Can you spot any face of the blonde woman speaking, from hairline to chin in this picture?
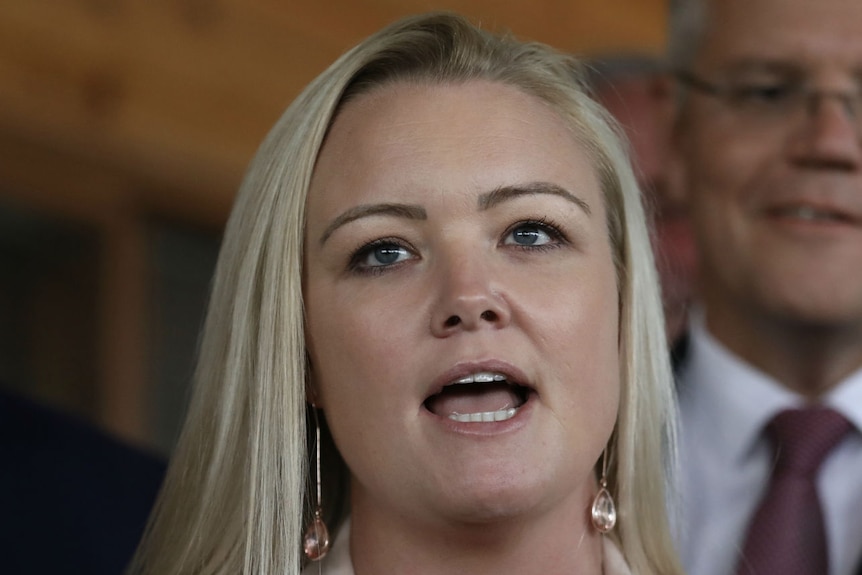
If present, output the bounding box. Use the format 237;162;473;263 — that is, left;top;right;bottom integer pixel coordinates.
304;81;620;521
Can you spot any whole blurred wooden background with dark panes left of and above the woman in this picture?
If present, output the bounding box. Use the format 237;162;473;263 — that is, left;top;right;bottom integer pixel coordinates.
0;0;665;454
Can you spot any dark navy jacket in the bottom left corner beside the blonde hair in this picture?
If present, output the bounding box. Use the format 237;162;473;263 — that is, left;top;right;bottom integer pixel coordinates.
0;392;164;575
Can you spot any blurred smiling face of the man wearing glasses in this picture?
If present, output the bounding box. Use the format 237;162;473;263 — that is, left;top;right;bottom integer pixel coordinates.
674;0;862;348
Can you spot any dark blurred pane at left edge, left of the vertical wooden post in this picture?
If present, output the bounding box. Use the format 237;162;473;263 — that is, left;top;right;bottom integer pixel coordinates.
0;199;102;420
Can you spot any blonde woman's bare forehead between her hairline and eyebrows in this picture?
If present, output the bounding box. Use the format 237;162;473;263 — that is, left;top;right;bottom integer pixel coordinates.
313;80;592;197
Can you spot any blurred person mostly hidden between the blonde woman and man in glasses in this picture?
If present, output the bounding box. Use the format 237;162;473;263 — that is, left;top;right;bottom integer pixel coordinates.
591;56;696;343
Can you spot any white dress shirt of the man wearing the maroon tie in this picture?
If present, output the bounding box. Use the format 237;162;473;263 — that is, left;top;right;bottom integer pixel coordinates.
676;313;862;575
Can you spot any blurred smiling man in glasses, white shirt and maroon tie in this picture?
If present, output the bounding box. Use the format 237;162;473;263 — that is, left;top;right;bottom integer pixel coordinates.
670;0;862;575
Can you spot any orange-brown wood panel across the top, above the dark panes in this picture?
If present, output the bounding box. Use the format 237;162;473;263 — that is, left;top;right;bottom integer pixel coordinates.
0;0;664;225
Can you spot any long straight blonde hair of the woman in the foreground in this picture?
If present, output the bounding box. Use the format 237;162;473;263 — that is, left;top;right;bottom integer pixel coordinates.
132;14;681;575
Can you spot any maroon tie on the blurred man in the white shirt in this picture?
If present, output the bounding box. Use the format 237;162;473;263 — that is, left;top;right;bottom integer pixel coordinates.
737;407;851;575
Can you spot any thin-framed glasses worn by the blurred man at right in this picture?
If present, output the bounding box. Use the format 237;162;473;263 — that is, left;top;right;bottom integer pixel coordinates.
676;71;862;133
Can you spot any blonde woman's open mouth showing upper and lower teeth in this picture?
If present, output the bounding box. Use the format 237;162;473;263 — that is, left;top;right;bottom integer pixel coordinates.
425;372;531;423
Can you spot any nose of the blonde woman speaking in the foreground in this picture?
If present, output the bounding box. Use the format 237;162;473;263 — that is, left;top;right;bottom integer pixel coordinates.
431;259;511;337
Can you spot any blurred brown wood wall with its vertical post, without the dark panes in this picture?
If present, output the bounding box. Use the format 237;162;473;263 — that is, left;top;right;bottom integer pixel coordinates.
0;0;665;450
